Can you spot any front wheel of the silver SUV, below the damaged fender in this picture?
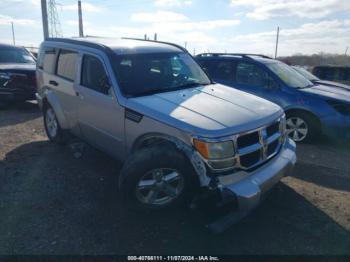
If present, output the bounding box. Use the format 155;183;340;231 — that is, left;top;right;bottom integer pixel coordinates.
119;143;198;210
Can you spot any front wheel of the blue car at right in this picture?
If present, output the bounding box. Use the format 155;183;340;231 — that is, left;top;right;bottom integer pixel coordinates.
286;112;320;143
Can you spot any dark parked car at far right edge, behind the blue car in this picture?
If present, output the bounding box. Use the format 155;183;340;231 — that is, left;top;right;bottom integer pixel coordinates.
312;66;350;85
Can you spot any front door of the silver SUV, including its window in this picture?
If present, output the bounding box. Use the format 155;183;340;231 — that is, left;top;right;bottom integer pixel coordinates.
76;53;125;158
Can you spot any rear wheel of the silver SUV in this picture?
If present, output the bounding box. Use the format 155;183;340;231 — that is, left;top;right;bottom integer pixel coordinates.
44;105;68;145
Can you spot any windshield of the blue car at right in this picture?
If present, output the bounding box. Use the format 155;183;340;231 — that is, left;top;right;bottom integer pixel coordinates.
266;61;313;88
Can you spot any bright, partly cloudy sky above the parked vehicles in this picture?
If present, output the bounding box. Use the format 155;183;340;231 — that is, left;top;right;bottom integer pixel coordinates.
0;0;350;55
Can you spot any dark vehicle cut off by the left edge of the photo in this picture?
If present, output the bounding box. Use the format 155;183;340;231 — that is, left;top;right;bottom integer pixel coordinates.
0;44;36;105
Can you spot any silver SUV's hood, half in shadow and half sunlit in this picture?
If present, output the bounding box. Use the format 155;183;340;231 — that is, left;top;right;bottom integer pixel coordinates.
128;84;283;137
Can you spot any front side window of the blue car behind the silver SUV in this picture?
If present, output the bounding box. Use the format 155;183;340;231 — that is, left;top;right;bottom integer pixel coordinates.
236;63;277;88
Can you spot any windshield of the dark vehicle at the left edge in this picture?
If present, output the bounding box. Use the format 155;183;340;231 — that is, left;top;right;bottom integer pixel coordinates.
0;48;35;64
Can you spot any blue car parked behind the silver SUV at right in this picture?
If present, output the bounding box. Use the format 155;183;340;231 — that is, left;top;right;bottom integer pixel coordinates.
196;53;350;142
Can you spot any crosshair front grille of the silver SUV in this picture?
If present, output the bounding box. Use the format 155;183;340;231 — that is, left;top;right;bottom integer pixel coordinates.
236;118;283;169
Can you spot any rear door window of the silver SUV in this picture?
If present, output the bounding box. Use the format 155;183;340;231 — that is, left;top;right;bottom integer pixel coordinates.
56;50;78;81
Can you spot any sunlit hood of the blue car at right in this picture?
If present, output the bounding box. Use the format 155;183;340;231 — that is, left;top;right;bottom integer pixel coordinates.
299;84;350;102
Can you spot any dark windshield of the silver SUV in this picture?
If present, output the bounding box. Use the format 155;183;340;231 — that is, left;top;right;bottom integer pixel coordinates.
116;53;211;97
